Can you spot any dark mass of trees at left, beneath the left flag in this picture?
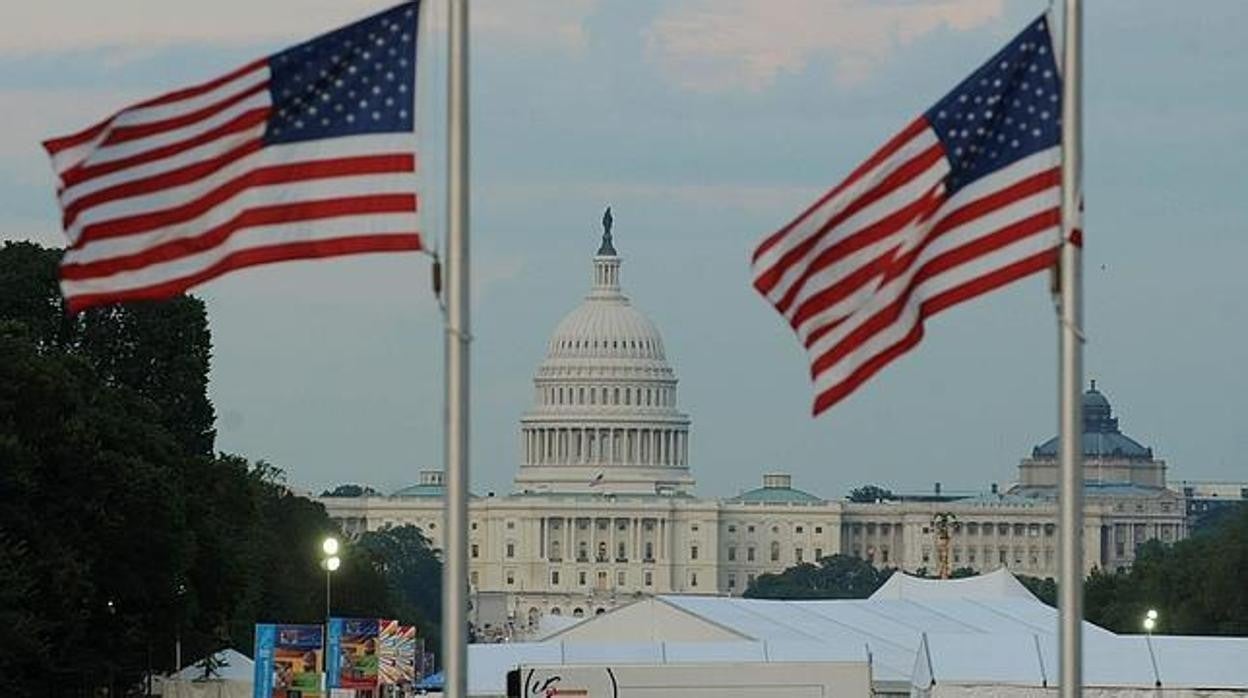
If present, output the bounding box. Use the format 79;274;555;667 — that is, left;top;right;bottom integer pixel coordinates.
0;242;441;696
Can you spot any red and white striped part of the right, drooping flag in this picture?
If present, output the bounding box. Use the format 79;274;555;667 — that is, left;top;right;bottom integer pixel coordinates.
754;117;1061;415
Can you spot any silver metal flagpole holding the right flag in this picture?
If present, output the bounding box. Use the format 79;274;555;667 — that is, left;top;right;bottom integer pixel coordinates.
1057;0;1083;698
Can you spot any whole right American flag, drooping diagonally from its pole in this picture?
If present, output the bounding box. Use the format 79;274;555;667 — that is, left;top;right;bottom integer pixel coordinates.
753;16;1062;415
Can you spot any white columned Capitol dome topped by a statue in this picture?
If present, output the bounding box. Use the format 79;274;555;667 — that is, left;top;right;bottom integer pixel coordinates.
515;219;693;494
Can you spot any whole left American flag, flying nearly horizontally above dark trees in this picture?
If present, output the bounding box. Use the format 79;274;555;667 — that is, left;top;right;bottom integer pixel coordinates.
44;1;422;311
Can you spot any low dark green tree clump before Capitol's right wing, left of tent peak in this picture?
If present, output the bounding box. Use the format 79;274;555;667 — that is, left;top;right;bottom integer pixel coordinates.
745;554;895;599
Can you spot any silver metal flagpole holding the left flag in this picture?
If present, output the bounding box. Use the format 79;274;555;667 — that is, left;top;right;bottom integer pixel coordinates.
442;0;470;698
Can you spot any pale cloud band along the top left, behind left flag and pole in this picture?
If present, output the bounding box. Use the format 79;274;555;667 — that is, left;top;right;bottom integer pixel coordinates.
0;0;597;57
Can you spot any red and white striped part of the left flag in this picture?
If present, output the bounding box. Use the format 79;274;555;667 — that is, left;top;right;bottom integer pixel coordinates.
44;60;422;311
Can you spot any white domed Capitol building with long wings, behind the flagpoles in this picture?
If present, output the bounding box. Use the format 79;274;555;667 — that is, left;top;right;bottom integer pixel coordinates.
319;224;1187;626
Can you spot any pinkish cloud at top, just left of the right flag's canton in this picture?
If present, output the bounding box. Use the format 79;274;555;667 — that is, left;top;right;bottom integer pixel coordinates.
644;0;1002;92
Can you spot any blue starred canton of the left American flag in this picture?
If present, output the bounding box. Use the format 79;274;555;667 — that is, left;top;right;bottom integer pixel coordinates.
265;1;419;144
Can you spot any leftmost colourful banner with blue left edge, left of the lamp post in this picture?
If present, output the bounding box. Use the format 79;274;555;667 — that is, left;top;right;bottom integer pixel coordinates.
252;623;324;698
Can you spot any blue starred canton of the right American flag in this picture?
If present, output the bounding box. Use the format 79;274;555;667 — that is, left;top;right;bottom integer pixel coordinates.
926;17;1062;195
